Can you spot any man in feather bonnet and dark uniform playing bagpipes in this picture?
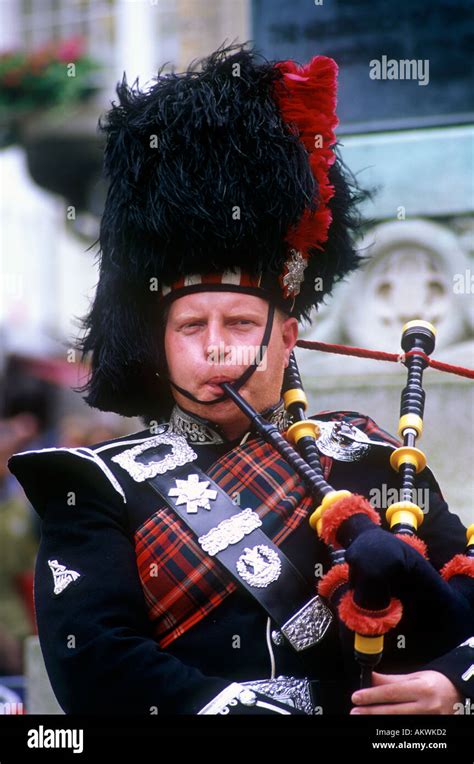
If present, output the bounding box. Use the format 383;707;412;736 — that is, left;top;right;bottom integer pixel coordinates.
9;46;473;715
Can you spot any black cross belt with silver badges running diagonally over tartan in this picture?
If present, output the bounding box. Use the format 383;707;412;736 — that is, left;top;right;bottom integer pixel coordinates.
147;464;332;652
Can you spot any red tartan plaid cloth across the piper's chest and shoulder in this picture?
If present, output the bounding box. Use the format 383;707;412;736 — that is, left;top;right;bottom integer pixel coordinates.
135;412;398;648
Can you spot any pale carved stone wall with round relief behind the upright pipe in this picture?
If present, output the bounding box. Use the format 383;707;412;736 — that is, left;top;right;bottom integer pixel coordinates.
298;215;474;524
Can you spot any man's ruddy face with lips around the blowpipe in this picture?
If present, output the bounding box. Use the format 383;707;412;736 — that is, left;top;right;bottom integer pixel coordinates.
165;292;298;438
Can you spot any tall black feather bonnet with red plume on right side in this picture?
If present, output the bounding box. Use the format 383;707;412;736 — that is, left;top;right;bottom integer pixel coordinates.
77;45;366;421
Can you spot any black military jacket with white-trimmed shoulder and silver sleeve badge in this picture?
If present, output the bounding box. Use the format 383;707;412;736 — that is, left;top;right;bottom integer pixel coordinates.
9;407;474;715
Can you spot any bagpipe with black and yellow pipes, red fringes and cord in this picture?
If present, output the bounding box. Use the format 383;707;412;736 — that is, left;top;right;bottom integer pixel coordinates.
221;320;474;687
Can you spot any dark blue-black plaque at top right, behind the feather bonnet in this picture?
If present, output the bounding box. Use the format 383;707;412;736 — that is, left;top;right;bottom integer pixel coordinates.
252;0;474;132
